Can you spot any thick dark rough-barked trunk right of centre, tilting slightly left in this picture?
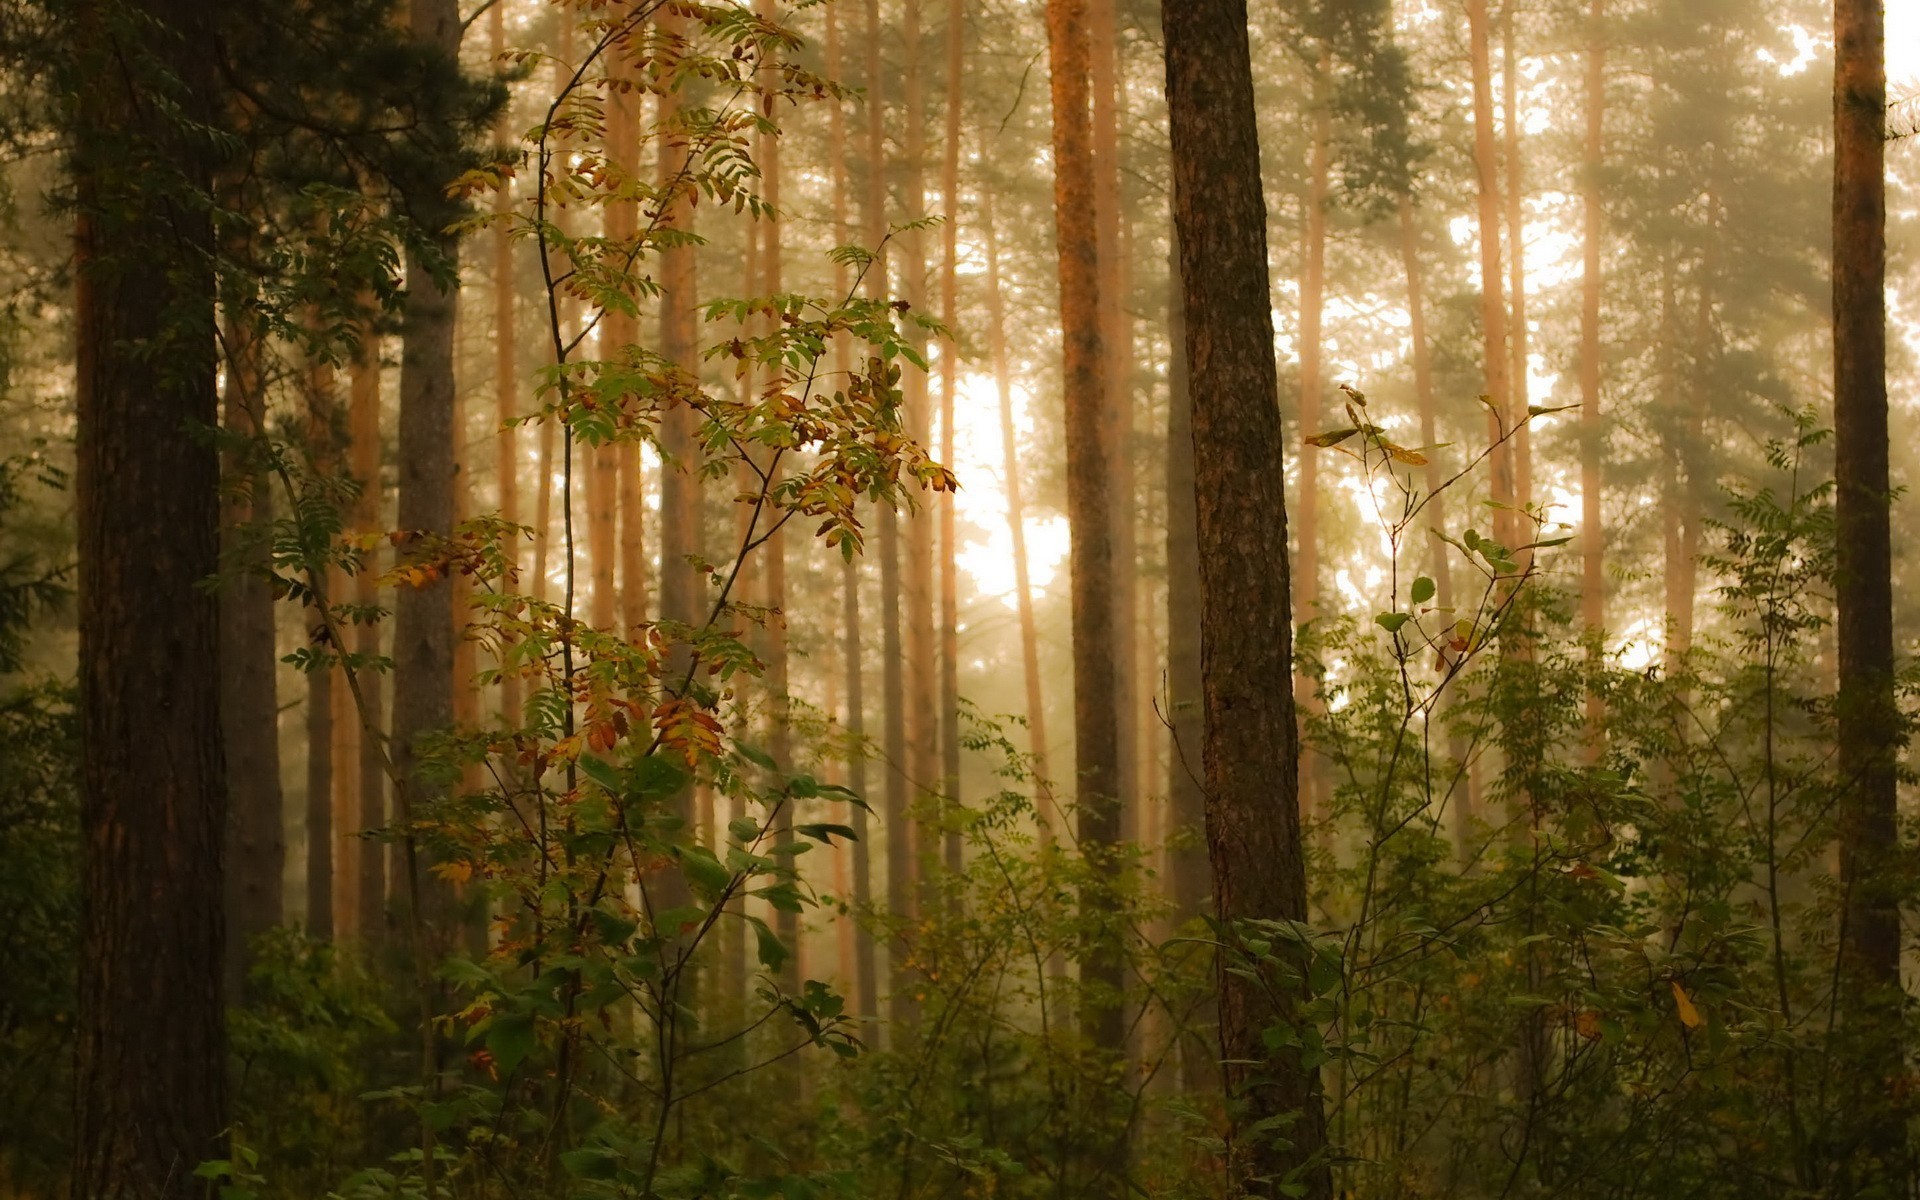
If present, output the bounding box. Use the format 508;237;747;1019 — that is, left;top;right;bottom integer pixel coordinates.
1160;0;1332;1200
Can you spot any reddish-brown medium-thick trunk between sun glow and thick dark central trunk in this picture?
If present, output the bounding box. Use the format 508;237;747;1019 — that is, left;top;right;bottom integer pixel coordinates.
1046;0;1125;1050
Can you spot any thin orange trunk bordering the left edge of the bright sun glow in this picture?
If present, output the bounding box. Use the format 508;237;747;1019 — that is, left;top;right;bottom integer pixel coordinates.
935;0;966;874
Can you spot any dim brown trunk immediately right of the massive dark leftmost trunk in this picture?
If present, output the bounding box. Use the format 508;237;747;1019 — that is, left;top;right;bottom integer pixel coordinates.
219;315;286;1000
